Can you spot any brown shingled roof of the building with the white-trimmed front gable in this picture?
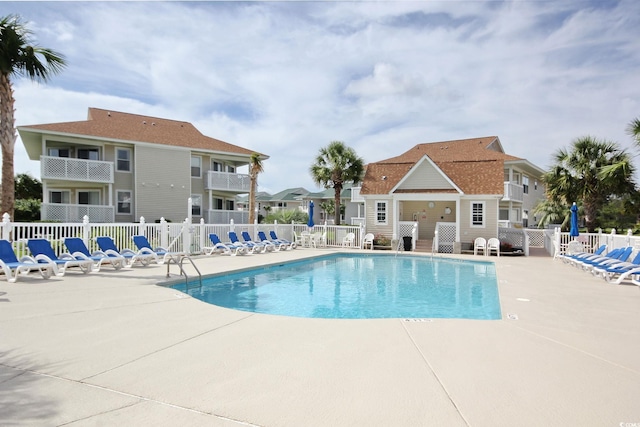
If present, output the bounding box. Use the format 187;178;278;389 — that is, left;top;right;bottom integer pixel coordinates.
360;136;522;194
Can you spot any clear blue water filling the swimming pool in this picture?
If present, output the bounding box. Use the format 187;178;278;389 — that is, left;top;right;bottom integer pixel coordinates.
173;254;501;319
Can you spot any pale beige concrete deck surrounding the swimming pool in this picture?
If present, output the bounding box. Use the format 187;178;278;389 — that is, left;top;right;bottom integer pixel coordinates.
0;249;640;427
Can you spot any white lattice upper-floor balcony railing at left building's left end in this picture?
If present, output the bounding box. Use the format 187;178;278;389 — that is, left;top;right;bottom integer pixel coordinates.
40;156;113;183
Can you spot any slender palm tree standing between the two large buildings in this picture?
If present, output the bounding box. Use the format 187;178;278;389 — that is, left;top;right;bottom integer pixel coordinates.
310;141;364;225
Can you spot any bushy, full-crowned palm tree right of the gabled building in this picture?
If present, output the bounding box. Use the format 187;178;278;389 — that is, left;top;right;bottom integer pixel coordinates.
544;136;635;232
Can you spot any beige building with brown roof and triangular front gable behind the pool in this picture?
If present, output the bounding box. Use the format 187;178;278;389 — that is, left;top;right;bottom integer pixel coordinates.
353;136;544;249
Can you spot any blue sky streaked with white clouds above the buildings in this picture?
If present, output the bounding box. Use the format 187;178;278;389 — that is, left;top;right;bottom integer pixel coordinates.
5;0;640;193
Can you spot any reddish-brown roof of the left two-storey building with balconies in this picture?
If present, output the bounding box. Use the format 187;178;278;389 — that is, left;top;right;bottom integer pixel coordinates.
18;108;268;158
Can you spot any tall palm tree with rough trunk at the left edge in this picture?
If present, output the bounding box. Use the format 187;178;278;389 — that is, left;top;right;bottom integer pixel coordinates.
0;15;65;216
